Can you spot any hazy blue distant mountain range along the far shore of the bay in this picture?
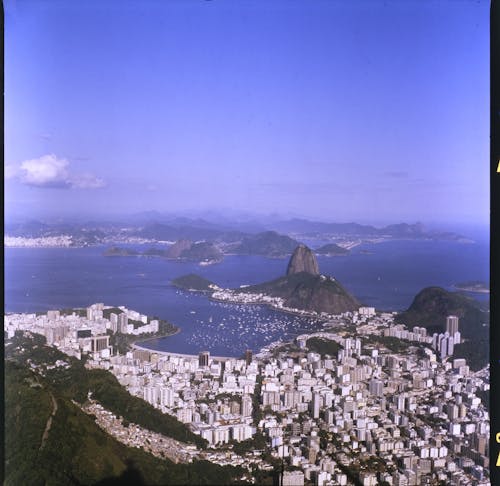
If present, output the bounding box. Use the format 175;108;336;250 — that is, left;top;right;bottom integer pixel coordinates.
5;218;465;249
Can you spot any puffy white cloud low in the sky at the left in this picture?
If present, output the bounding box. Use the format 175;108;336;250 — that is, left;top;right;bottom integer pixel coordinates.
9;154;106;189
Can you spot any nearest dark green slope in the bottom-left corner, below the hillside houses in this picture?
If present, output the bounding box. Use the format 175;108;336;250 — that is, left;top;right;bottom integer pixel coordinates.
4;361;247;486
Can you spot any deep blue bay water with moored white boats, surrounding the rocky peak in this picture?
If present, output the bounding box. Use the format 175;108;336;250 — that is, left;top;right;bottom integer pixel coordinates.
5;240;489;356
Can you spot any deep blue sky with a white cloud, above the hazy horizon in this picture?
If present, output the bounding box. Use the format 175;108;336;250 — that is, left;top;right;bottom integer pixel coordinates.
5;0;489;224
